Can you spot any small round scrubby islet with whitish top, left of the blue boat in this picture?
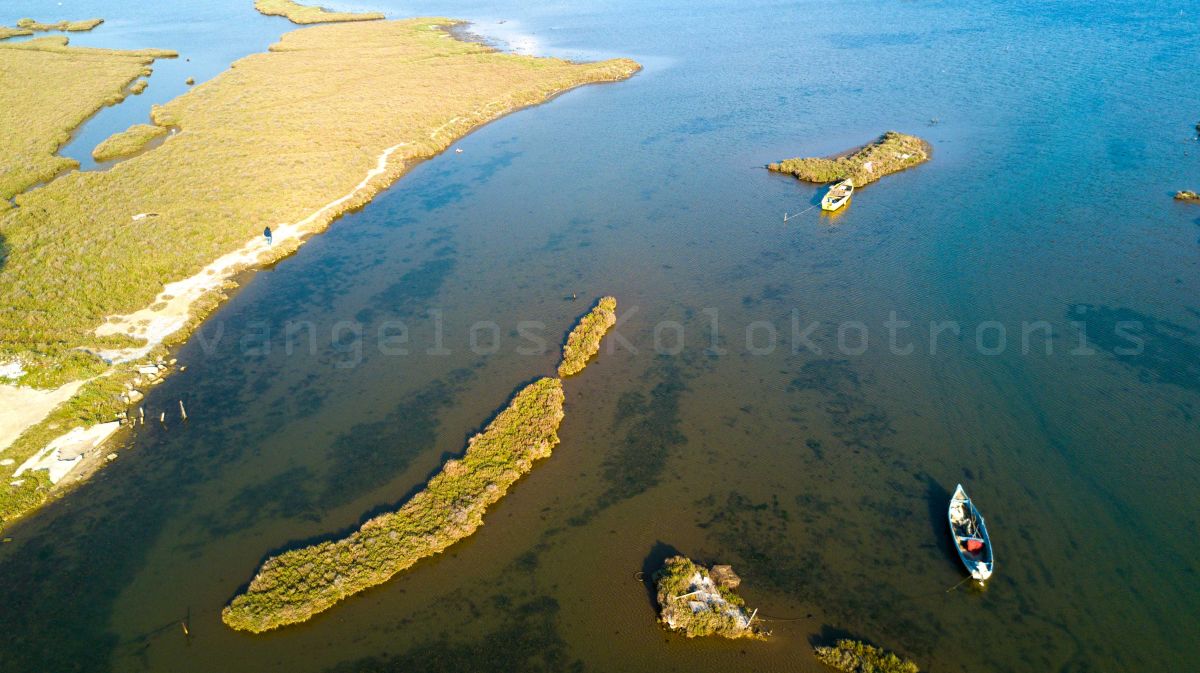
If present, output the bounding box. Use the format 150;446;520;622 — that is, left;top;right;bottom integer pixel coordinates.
654;557;768;638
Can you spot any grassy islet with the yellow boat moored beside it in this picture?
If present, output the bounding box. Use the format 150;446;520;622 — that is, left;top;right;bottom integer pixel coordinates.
767;131;930;187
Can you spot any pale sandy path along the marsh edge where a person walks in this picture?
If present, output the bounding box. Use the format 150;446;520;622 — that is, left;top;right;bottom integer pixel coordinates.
96;143;408;362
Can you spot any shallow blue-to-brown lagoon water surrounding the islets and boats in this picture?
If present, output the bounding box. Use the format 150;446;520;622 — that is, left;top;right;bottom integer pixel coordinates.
0;1;1200;672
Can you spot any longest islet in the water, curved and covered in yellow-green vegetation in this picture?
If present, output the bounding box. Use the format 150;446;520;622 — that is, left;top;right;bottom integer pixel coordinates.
221;378;563;633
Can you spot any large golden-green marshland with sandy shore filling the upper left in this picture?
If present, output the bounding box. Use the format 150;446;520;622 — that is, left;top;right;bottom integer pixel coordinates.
0;18;640;525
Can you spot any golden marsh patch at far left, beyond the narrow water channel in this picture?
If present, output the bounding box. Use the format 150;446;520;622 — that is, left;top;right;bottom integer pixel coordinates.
0;36;176;197
